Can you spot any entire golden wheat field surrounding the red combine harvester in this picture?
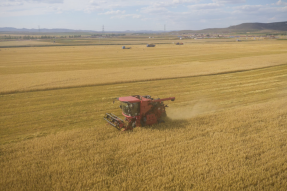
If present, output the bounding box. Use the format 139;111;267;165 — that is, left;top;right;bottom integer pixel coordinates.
0;38;287;190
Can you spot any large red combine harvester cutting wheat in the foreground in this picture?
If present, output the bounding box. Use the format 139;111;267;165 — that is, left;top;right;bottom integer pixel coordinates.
104;95;175;131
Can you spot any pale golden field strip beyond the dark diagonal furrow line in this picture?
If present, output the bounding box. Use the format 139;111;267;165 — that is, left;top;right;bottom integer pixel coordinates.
0;41;287;92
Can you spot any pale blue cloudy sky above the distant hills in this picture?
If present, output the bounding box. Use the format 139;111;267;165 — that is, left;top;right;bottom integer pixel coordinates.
0;0;287;31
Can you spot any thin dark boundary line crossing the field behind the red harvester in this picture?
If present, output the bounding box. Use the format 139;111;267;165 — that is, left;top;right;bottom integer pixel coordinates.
0;63;287;95
